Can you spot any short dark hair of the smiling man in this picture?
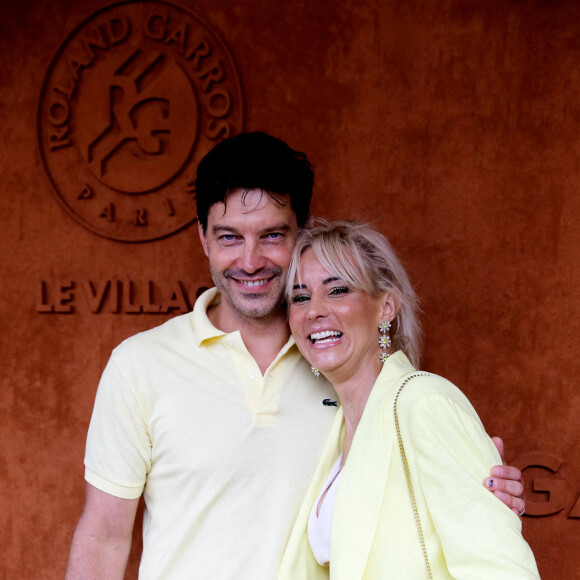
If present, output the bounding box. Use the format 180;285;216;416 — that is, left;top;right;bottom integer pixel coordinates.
195;132;314;232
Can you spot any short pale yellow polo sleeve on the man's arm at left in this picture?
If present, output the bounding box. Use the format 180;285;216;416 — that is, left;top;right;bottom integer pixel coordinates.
85;354;151;499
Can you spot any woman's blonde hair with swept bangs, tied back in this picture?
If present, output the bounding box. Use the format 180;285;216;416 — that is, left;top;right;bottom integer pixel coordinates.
286;219;421;367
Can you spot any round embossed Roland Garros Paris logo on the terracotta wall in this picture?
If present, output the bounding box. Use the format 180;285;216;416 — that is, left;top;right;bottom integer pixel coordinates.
38;0;243;242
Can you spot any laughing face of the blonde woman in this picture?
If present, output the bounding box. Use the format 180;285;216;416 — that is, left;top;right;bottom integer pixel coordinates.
289;249;394;383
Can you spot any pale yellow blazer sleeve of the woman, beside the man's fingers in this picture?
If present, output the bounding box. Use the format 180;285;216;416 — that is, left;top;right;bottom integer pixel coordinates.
401;376;539;580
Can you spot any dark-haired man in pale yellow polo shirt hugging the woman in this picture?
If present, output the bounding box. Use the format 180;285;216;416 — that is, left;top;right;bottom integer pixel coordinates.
67;133;523;580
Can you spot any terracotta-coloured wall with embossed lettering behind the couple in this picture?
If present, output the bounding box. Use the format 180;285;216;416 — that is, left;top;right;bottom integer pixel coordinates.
0;0;580;580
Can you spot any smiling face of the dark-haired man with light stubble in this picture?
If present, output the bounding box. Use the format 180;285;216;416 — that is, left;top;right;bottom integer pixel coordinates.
199;188;298;319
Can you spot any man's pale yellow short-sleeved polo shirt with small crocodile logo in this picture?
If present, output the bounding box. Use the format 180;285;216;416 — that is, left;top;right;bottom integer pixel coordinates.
85;289;336;580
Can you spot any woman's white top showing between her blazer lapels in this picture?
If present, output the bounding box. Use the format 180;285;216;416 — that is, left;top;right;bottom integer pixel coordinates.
308;453;342;566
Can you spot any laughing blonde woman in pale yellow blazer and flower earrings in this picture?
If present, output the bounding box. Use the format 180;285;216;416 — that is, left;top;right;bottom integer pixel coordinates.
278;222;539;580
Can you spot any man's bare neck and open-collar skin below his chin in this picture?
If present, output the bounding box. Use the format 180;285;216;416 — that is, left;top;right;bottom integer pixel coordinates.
207;301;290;374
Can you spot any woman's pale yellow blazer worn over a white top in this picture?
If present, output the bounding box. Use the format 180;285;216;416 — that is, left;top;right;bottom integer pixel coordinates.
278;351;539;580
